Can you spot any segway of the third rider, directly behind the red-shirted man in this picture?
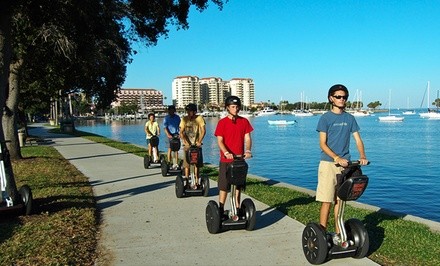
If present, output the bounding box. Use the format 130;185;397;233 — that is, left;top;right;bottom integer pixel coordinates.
176;145;209;198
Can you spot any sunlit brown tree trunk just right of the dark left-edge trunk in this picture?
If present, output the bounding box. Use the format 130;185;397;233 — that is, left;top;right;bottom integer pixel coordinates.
2;59;23;160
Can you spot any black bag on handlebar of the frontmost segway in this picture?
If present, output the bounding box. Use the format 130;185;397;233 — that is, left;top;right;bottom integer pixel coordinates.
336;166;368;201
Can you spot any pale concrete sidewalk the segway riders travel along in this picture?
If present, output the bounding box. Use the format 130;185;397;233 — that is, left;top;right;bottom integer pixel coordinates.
29;124;377;265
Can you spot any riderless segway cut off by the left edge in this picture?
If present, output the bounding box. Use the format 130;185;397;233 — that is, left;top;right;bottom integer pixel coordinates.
0;142;33;215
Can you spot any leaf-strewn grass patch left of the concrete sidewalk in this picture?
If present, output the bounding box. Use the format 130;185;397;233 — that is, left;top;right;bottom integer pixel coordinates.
0;146;99;265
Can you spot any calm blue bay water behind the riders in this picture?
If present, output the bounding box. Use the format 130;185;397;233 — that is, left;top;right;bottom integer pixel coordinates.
77;114;440;222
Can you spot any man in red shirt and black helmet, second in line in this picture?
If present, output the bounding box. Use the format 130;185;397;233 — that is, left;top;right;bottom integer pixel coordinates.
214;96;254;215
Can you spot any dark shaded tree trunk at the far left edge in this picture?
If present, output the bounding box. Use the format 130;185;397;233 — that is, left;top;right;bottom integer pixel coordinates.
0;1;19;201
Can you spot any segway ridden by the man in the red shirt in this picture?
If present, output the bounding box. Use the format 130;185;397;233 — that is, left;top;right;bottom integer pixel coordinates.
206;157;256;234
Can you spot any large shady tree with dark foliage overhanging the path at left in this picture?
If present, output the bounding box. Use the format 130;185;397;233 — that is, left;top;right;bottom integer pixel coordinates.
0;0;227;203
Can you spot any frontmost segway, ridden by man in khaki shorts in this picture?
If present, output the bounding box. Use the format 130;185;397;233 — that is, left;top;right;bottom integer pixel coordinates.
302;161;370;264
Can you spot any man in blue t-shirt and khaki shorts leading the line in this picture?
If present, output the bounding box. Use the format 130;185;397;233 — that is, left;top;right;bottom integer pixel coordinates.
316;84;368;242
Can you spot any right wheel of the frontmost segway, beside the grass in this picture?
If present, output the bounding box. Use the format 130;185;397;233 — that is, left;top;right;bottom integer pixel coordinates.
345;219;370;259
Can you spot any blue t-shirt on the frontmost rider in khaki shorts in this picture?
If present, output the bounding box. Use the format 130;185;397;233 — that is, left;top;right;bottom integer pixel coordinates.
316;111;359;162
